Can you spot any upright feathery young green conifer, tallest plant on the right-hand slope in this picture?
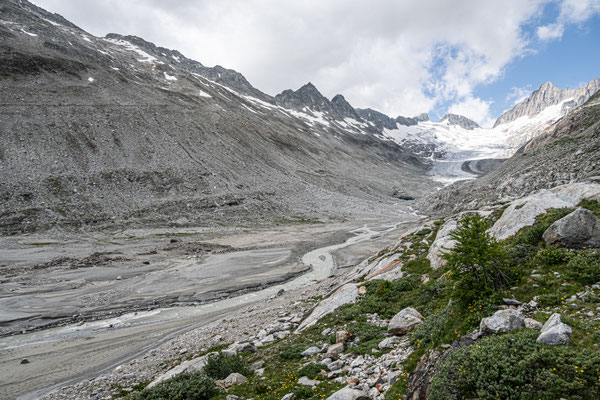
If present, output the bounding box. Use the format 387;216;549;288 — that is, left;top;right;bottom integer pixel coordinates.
444;214;516;306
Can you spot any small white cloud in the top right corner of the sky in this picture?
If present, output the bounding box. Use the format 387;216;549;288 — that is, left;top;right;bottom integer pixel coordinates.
537;0;600;41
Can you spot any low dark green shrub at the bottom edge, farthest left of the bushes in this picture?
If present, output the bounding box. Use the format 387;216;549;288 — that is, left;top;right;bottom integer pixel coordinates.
132;372;218;400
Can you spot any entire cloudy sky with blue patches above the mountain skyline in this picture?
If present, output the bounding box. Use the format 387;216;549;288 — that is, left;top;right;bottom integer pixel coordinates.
33;0;600;126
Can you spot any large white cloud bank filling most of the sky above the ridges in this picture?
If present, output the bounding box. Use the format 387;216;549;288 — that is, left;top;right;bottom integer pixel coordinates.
33;0;548;118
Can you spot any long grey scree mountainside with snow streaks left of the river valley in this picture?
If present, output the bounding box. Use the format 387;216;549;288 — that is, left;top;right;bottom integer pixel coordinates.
0;0;434;233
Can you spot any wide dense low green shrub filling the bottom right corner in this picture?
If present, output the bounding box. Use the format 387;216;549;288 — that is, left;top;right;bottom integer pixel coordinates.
429;331;600;400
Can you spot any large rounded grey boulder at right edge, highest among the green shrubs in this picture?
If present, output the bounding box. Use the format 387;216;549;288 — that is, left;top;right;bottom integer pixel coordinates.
543;207;600;249
